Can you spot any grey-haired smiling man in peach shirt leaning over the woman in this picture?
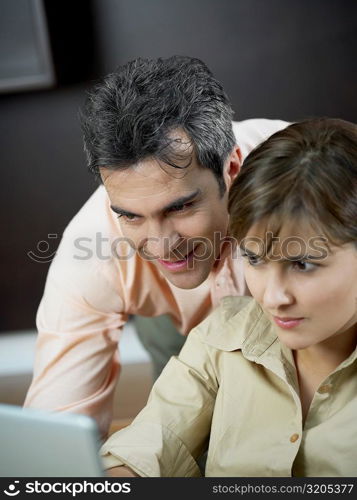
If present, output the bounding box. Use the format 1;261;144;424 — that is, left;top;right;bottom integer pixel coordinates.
25;56;287;435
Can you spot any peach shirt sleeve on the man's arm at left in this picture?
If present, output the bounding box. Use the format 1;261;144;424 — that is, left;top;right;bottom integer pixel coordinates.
24;188;126;437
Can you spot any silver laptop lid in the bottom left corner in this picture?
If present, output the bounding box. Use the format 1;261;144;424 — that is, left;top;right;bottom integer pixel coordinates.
0;404;105;477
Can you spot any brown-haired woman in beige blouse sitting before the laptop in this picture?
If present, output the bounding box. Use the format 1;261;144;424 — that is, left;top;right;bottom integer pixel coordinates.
98;119;357;477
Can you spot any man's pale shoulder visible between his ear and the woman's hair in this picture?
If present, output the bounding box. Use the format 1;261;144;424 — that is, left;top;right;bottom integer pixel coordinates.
233;118;290;159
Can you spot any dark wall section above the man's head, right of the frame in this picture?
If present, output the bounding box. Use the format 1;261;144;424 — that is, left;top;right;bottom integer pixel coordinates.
93;0;357;120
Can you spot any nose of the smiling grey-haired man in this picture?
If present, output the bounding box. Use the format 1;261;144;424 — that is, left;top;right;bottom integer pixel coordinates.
143;224;183;260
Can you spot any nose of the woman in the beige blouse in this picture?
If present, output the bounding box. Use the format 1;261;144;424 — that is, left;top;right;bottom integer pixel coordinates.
263;272;294;311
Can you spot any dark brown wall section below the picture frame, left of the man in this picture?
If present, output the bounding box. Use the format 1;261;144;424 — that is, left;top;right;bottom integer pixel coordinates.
0;86;96;331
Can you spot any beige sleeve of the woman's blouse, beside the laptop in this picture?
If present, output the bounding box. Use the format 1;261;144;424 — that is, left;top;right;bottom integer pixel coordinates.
101;328;218;477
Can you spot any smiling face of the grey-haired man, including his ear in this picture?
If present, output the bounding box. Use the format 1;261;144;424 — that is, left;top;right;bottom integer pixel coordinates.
101;135;240;289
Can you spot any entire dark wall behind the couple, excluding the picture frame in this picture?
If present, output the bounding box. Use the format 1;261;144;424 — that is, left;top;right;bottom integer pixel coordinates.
0;0;357;331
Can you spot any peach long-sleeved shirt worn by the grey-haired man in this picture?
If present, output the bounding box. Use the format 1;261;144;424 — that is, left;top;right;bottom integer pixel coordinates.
25;119;288;435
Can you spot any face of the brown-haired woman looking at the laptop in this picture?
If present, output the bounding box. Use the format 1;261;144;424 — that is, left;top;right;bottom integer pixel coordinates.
241;223;357;349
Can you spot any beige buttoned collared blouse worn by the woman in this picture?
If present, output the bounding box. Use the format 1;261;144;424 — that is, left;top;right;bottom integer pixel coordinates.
101;297;357;477
